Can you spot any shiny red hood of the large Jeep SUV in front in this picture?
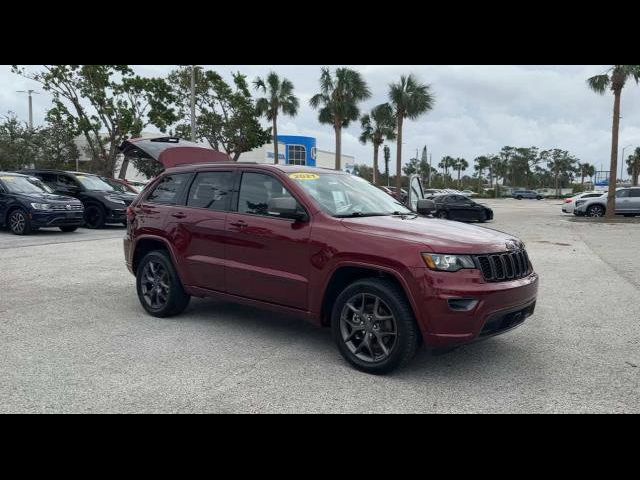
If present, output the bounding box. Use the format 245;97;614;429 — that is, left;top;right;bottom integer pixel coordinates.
342;216;519;254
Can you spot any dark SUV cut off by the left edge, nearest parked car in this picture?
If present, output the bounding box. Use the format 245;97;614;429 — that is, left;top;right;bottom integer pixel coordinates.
0;172;84;235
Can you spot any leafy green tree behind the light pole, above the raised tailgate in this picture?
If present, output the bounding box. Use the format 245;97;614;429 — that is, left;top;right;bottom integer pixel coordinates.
169;68;271;161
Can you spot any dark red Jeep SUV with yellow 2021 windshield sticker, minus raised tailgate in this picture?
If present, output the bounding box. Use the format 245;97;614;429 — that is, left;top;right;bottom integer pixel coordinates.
124;138;538;373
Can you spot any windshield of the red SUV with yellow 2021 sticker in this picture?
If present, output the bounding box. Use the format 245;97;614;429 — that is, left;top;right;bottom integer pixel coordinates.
289;173;412;217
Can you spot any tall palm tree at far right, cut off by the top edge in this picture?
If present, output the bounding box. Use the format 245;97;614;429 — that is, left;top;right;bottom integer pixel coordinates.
587;65;640;218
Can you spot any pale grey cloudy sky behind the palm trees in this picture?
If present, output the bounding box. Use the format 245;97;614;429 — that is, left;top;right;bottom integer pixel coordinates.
0;65;640;174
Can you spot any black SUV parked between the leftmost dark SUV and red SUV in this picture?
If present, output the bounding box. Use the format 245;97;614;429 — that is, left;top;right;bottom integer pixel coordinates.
20;170;136;228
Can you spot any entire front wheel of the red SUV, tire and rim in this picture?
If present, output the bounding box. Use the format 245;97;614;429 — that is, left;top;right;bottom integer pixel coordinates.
331;278;420;374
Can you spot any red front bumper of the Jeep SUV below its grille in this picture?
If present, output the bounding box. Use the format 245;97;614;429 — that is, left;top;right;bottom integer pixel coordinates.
413;268;538;347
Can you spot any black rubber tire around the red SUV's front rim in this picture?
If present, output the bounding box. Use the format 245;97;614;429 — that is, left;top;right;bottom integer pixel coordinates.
331;278;421;374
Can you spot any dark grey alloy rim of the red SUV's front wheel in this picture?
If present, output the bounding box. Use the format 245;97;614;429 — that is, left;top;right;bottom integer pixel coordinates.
340;293;398;363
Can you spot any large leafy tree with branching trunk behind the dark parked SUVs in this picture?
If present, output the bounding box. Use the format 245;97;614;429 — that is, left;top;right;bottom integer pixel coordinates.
12;65;176;176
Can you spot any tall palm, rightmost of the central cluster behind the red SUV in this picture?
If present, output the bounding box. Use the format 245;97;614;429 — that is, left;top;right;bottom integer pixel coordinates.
389;74;434;199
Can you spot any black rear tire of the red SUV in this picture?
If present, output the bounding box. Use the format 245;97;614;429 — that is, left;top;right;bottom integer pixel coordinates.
136;250;191;318
